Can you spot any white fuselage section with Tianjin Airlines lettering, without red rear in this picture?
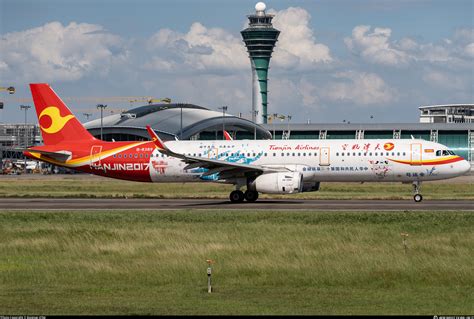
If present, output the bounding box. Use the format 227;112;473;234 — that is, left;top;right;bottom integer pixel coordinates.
150;139;470;182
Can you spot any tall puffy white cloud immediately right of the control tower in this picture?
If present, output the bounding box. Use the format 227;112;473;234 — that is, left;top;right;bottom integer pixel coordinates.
272;7;333;68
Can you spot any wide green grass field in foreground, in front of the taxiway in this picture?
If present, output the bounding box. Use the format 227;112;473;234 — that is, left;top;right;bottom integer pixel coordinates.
0;211;474;315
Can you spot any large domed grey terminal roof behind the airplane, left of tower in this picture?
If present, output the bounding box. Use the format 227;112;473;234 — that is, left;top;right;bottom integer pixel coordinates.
84;103;271;141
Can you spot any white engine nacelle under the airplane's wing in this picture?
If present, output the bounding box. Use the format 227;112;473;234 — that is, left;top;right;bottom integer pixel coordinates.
247;172;303;194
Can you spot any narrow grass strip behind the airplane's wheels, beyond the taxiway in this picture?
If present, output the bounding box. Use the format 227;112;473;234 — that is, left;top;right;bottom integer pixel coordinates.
0;175;474;200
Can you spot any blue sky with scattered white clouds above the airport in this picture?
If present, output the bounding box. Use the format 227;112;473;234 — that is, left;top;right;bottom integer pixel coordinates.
0;0;474;123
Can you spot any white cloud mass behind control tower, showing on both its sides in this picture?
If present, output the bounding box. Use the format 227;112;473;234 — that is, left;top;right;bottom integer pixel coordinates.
145;8;333;72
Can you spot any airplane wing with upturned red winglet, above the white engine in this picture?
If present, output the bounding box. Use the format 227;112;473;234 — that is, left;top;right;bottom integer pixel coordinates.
146;126;281;179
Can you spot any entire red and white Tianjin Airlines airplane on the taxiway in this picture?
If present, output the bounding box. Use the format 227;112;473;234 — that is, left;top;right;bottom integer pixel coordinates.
24;83;470;203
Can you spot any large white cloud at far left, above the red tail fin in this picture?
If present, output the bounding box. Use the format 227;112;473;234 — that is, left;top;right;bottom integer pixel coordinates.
0;22;127;81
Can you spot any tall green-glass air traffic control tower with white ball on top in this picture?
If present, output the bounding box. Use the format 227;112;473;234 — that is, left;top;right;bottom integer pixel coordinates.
240;2;280;124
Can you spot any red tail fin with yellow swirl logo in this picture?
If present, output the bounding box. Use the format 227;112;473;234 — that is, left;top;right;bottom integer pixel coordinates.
30;83;95;145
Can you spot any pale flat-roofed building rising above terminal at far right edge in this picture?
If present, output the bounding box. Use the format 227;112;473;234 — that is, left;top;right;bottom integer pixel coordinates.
419;104;474;123
